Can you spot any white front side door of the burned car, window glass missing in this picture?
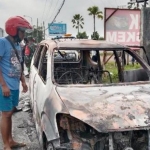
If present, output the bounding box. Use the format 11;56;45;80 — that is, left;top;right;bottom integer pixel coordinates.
34;46;49;127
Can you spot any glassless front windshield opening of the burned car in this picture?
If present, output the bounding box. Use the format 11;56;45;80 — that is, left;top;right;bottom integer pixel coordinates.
53;49;149;84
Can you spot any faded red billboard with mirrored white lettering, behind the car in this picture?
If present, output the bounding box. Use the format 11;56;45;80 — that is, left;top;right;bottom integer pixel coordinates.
105;8;141;45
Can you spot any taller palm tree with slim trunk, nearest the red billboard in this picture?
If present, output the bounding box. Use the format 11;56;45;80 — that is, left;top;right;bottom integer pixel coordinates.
88;6;103;33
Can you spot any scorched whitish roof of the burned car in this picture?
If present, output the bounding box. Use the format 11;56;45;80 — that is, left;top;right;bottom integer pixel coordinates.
41;39;130;50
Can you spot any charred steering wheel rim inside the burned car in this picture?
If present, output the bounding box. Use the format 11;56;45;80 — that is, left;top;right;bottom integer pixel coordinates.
57;71;84;84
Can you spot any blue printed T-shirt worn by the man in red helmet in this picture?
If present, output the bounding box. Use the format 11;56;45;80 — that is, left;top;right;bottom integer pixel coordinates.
0;38;21;90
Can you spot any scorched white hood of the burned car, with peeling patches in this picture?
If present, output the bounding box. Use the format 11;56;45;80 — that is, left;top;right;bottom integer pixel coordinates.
56;84;150;132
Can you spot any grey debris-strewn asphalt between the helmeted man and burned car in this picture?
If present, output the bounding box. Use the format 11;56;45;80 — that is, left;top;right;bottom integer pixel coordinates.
0;78;41;150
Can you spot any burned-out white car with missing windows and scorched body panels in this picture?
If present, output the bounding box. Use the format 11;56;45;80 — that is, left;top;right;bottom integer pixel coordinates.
29;39;150;150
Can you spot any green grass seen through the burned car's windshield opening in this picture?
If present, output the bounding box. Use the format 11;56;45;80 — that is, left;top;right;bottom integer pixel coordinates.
102;62;141;83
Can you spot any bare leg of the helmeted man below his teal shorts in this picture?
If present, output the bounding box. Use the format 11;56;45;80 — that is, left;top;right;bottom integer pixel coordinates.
1;111;12;150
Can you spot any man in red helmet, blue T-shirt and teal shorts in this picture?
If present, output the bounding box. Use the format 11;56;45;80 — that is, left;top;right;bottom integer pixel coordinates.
0;16;32;150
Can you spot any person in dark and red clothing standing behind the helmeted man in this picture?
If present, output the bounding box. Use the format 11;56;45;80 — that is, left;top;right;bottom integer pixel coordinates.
24;36;36;78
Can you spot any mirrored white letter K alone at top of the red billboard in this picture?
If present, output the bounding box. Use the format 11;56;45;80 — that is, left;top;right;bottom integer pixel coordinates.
129;14;139;30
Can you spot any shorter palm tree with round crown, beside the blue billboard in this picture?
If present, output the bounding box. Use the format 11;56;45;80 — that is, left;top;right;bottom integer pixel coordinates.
72;14;84;34
